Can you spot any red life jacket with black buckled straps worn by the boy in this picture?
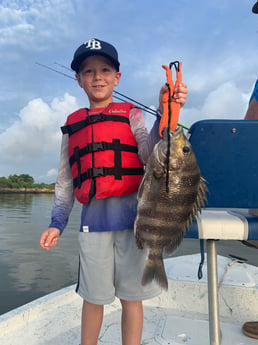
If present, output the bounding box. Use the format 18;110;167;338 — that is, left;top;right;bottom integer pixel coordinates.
61;103;144;204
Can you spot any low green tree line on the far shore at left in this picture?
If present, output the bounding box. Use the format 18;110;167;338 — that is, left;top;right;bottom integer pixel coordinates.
0;174;55;189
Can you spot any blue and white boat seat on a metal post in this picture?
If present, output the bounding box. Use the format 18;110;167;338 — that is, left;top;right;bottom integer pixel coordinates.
185;120;258;345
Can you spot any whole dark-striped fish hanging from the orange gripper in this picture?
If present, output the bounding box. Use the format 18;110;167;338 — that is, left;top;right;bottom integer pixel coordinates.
134;127;207;290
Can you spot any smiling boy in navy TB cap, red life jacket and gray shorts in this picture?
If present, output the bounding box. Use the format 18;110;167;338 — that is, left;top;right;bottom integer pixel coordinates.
40;39;187;345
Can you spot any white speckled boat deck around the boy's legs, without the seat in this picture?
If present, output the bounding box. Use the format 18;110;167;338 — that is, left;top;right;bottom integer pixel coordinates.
0;255;258;345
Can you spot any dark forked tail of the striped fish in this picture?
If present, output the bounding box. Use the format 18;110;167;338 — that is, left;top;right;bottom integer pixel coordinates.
142;253;168;290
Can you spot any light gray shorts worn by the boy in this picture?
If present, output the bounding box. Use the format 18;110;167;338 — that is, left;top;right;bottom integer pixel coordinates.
76;230;161;304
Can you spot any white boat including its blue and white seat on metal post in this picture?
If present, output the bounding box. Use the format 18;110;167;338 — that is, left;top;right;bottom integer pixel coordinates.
0;120;258;345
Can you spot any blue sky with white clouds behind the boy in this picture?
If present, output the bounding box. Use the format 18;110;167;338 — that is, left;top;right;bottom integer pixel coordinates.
0;0;258;183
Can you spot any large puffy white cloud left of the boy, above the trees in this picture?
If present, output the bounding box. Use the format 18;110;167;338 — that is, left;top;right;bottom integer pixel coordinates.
0;93;78;181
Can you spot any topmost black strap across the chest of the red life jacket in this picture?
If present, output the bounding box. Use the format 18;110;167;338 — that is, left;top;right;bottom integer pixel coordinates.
61;114;130;136
